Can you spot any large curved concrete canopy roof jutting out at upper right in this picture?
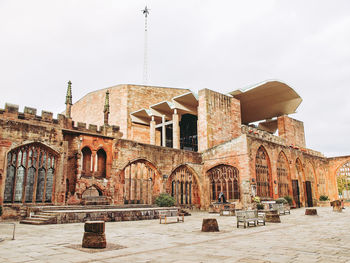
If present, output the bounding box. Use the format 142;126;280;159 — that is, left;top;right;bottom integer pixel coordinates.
229;80;302;124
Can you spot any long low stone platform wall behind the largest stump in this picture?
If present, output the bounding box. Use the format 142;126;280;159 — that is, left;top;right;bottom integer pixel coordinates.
50;207;177;224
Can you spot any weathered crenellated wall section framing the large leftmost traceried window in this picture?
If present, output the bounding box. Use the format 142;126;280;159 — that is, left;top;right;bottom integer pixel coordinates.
0;104;67;217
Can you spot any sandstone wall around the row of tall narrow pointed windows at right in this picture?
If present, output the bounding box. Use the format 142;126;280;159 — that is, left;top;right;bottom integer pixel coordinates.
247;134;336;206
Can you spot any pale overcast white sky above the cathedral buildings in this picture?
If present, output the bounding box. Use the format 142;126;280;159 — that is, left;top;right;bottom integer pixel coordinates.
0;0;350;157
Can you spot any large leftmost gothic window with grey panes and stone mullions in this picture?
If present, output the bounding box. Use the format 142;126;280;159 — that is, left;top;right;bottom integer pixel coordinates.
4;143;57;203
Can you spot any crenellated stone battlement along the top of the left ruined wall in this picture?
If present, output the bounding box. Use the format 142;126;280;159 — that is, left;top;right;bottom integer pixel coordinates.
0;103;121;138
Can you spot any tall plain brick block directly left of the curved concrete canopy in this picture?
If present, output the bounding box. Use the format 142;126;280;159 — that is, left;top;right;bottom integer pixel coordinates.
198;89;241;152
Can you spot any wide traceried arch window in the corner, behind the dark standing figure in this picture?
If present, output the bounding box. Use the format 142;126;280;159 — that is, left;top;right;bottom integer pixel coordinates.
207;164;240;201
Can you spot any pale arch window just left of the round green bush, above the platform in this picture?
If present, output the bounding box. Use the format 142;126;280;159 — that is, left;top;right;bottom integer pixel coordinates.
124;160;159;204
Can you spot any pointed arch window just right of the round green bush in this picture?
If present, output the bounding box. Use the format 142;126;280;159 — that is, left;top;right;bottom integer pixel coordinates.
168;165;200;205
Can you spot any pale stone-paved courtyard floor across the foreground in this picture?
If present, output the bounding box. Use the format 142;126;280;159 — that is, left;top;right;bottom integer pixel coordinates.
0;207;350;263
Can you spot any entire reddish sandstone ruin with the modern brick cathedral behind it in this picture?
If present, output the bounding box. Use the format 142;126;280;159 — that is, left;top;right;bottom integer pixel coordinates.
0;81;350;217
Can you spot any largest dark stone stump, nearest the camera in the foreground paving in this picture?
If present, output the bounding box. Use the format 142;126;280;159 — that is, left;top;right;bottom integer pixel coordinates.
82;221;107;248
